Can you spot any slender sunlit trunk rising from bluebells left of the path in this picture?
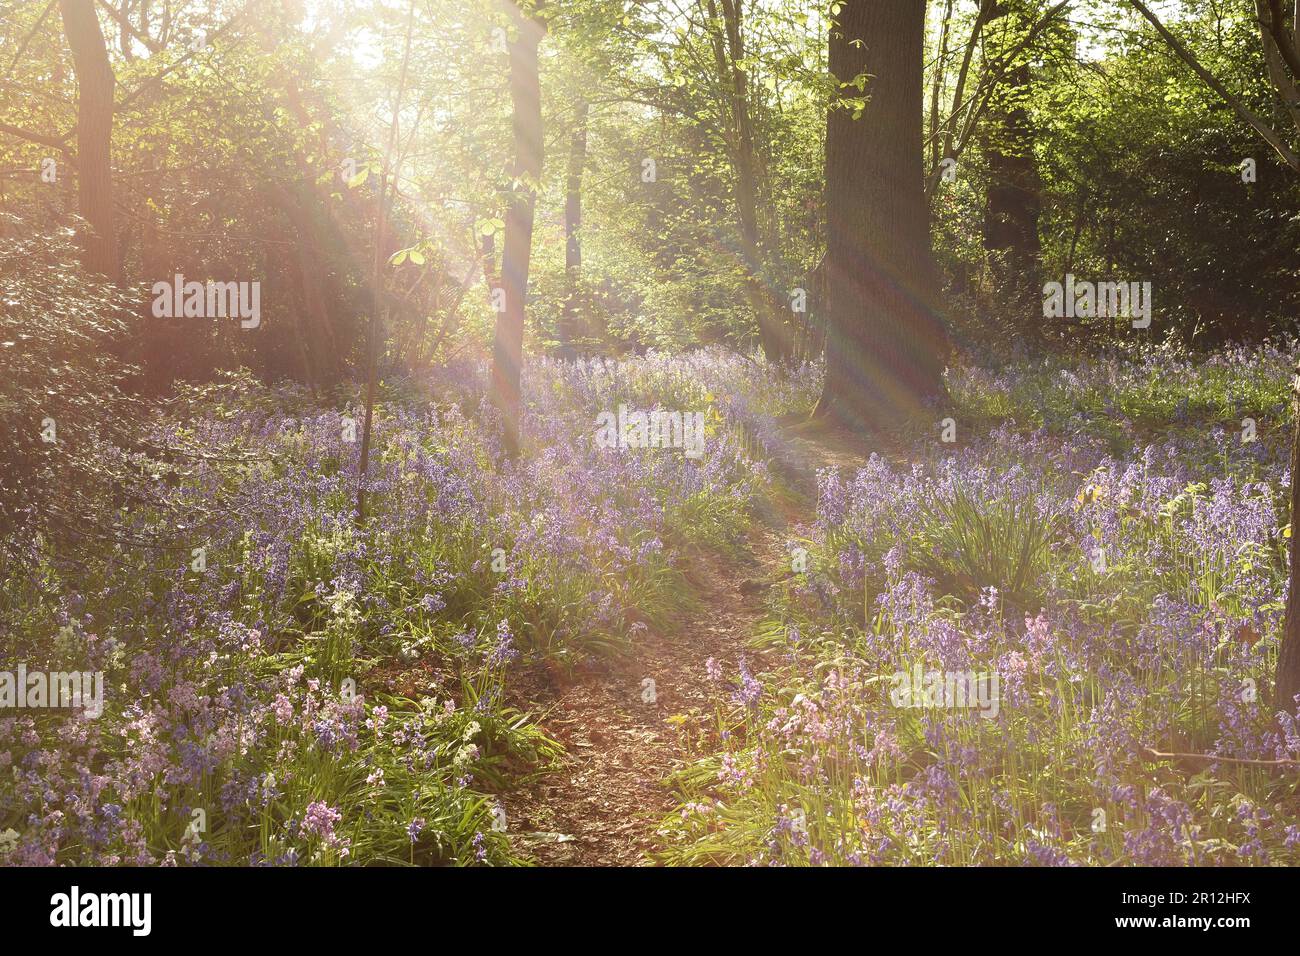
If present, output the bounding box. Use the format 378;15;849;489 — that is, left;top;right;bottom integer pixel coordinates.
491;7;545;455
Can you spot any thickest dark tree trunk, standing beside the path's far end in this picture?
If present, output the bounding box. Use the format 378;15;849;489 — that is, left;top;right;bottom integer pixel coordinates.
818;0;948;433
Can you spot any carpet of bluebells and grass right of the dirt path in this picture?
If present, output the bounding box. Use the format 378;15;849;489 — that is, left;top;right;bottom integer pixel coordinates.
677;347;1300;865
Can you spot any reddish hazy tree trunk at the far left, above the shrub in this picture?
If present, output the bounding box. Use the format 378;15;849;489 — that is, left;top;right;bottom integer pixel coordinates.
59;0;122;282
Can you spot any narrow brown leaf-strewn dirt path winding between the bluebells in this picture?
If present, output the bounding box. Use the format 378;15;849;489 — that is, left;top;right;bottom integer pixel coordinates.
502;421;865;866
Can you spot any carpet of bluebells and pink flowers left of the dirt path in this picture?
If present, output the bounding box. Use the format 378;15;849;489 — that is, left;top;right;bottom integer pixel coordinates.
0;354;800;865
